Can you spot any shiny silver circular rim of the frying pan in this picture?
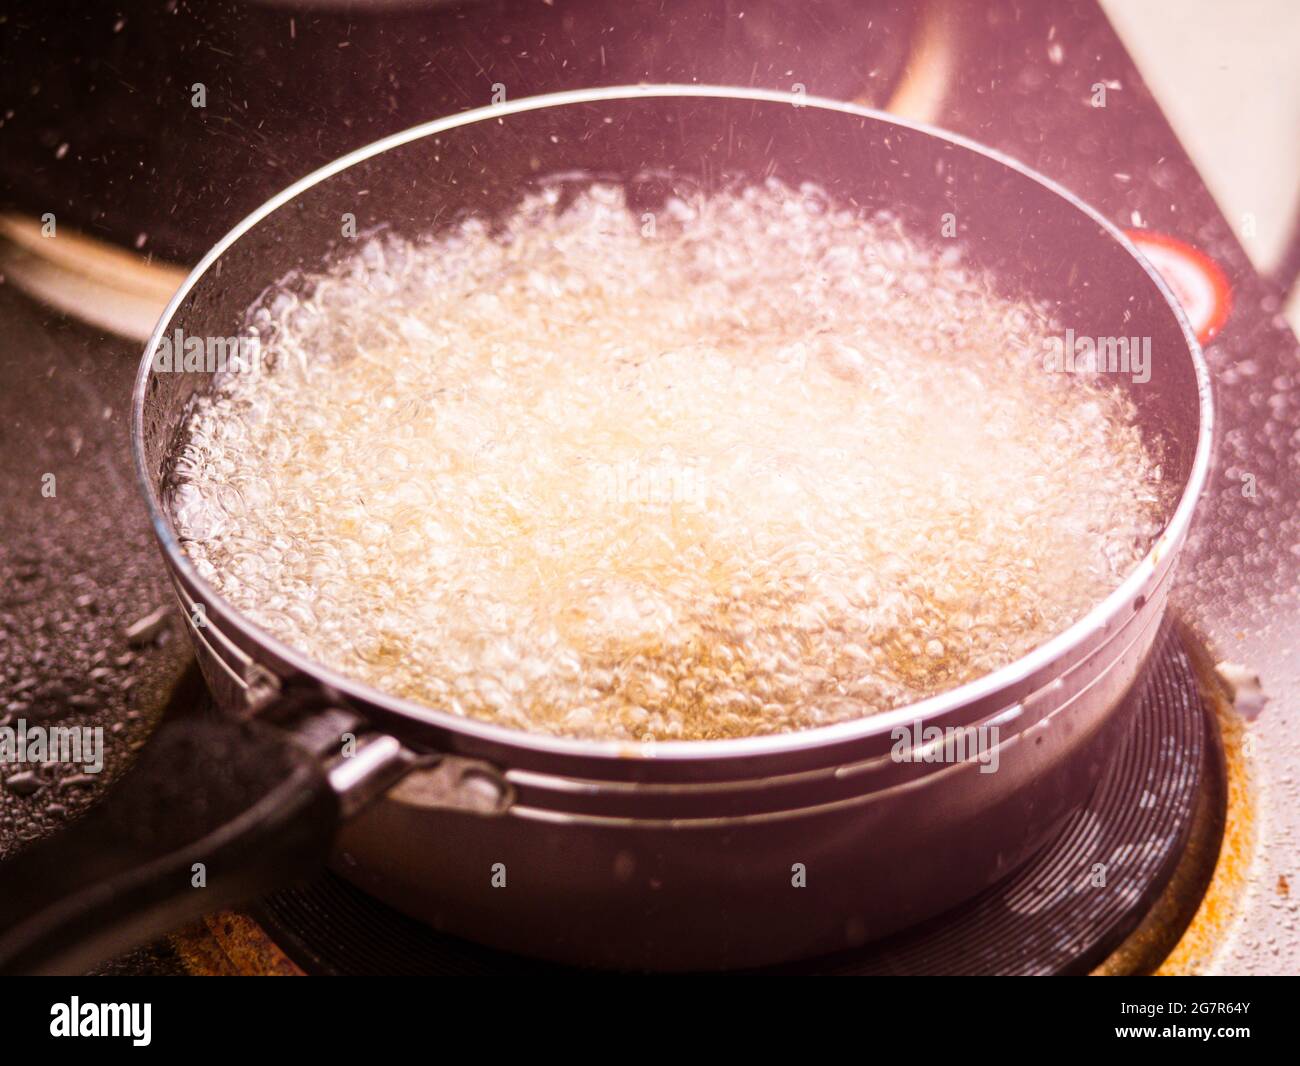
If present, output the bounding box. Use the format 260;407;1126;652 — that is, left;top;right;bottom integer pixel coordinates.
131;85;1214;762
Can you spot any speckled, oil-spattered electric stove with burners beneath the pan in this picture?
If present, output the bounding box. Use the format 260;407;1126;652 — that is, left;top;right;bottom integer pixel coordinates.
0;0;1300;974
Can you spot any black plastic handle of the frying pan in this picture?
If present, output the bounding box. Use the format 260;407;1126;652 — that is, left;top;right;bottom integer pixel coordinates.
0;712;405;974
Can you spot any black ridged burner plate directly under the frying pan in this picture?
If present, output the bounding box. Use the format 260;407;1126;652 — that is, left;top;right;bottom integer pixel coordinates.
255;629;1214;975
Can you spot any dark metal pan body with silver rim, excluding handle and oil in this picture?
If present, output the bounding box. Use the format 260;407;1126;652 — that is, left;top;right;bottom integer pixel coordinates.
134;86;1212;969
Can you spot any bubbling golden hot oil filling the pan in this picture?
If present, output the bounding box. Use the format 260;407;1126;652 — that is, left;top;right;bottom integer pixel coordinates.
173;183;1167;740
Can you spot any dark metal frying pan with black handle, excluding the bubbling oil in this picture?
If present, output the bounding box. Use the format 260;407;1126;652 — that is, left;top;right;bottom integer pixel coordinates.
0;86;1212;972
